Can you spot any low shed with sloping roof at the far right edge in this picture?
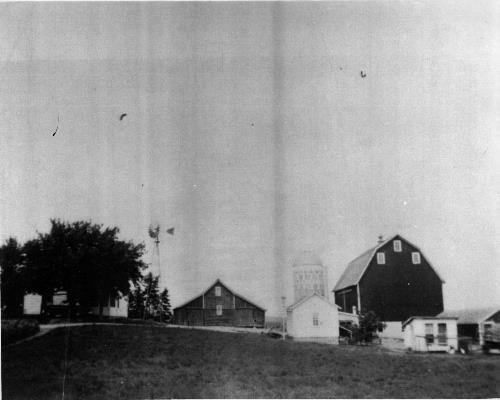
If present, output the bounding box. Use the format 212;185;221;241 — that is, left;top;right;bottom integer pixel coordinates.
438;307;500;345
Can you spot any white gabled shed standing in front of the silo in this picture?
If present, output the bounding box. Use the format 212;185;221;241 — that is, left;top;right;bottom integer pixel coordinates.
286;293;339;344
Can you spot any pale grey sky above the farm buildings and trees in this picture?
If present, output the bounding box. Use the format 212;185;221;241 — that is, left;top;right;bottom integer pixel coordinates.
0;1;500;315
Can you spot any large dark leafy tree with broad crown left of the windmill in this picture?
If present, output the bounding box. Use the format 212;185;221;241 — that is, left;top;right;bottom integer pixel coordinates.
24;220;146;314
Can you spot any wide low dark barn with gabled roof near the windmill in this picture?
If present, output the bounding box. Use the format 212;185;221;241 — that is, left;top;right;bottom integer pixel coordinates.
174;279;266;327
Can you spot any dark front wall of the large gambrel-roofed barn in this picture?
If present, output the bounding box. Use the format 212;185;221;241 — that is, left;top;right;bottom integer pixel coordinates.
359;238;443;321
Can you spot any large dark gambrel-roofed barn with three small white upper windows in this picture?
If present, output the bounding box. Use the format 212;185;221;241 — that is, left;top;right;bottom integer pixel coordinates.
334;235;444;338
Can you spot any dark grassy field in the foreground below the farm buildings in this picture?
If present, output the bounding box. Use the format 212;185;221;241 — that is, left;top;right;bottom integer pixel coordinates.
2;325;500;399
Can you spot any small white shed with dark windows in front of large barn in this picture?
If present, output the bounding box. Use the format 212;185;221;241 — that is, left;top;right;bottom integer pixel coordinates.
403;317;458;352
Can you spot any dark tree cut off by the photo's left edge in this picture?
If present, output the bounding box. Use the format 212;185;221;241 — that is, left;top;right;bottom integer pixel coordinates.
0;238;25;317
